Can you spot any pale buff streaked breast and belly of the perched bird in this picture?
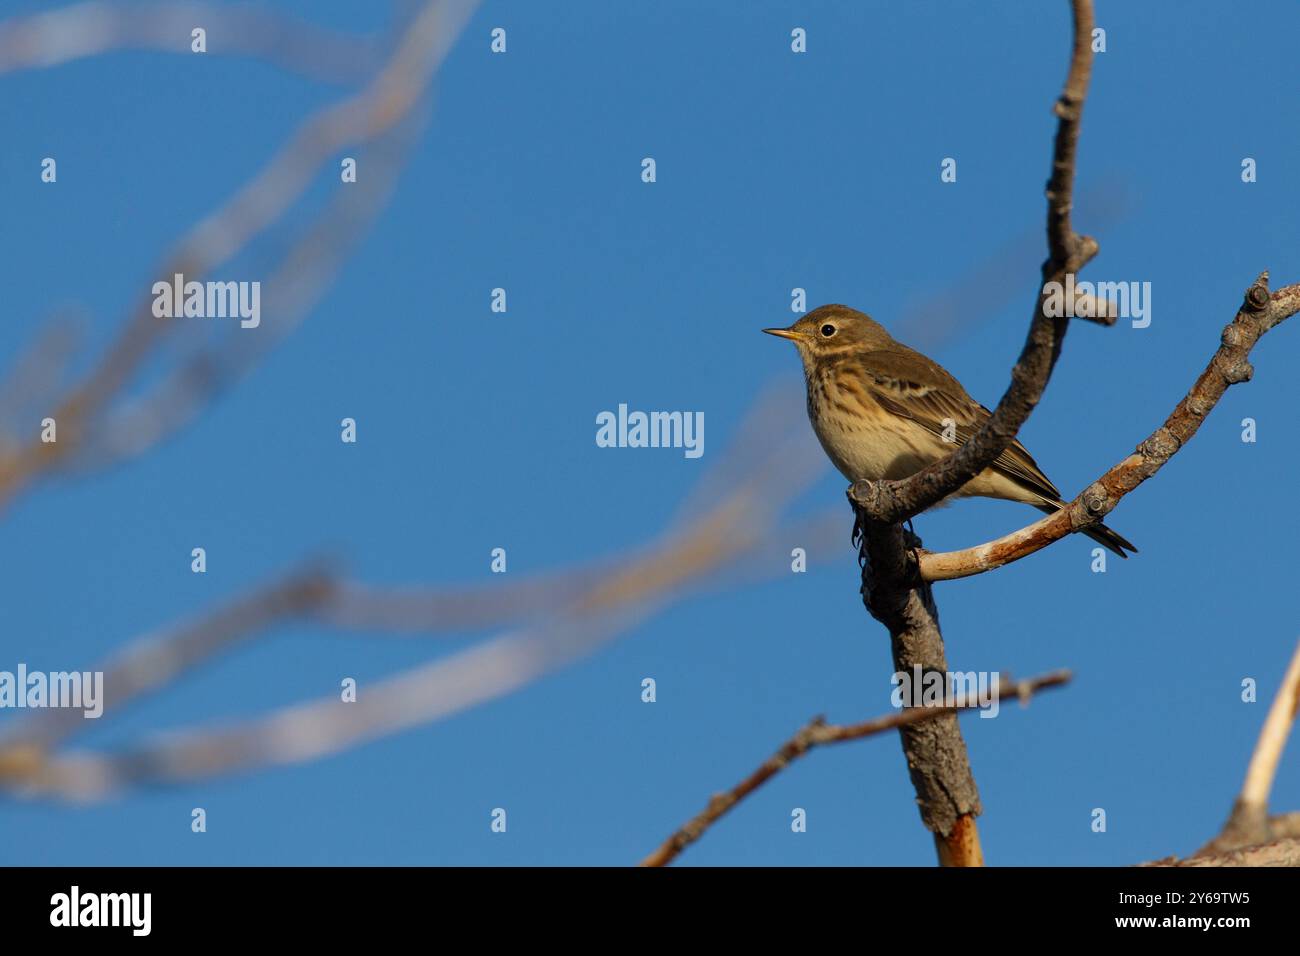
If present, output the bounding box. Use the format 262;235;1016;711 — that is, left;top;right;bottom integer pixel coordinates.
809;382;1047;506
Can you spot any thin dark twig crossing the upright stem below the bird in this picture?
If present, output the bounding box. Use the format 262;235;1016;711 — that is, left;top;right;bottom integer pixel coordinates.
641;670;1071;866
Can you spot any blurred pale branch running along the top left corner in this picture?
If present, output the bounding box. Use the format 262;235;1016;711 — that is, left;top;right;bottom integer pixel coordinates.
0;0;378;83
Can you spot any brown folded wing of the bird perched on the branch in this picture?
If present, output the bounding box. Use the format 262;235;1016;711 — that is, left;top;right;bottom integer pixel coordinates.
859;345;1061;502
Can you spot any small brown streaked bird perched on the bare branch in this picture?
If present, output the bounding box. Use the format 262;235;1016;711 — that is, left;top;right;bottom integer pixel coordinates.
763;306;1138;558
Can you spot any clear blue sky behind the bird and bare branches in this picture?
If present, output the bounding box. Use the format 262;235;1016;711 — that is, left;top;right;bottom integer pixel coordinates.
0;0;1300;865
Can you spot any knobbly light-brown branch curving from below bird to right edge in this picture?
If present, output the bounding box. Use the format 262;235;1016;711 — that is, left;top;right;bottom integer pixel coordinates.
918;272;1300;581
